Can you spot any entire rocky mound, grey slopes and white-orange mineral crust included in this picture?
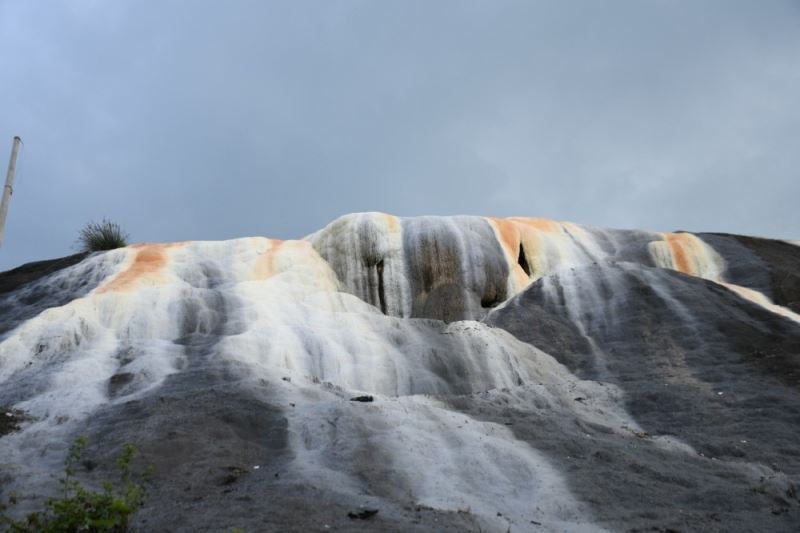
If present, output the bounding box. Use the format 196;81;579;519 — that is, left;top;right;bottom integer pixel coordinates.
0;213;800;531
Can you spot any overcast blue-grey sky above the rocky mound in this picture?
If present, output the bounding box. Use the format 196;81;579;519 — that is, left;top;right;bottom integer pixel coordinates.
0;0;800;270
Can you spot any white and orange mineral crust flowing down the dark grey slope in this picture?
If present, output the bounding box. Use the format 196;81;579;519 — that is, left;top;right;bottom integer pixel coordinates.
0;213;800;531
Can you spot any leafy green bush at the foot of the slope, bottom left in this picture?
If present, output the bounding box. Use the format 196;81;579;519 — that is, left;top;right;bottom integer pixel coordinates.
0;437;150;533
